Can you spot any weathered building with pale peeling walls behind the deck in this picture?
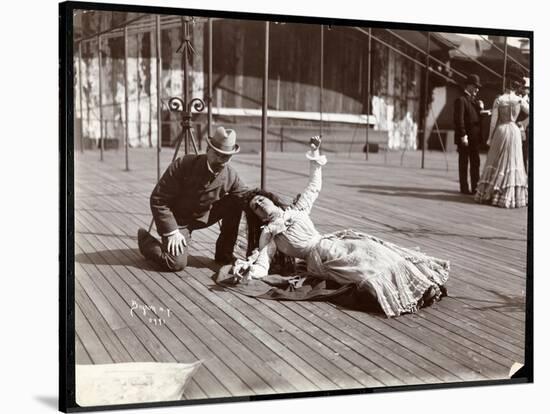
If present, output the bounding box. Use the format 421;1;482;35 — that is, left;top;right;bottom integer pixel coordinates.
75;11;529;152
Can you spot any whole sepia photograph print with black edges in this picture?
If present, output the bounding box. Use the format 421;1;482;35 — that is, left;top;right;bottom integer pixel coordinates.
59;2;533;411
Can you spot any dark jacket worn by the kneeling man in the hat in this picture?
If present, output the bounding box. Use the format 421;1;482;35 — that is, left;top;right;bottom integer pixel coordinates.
150;154;247;235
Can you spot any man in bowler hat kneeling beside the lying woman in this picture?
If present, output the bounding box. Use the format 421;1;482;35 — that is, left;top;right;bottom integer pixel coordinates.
138;127;247;272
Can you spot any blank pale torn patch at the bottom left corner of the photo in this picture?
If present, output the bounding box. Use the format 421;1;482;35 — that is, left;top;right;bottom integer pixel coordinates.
76;361;201;407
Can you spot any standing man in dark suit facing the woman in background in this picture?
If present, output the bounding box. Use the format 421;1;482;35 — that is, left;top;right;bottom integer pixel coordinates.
454;75;483;194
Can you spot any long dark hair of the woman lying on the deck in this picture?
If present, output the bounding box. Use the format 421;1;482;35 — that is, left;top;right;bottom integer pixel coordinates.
243;188;299;275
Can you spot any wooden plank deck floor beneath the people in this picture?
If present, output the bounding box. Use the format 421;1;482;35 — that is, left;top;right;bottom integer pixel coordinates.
75;149;527;399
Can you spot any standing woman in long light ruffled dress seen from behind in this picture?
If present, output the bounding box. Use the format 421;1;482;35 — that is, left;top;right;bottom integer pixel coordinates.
474;76;529;208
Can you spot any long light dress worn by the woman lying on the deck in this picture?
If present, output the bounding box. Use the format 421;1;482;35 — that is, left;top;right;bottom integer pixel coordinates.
250;153;449;317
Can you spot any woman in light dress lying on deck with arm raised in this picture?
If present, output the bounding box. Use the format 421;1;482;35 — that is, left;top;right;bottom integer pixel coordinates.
222;137;449;317
